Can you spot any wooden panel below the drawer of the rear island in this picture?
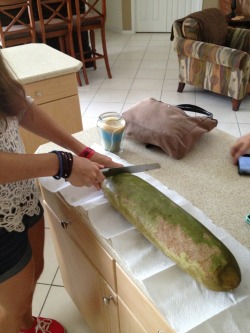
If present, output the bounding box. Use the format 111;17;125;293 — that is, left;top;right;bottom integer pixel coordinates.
20;95;82;153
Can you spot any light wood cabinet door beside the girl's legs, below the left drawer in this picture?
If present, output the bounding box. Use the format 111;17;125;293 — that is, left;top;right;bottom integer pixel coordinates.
44;201;105;333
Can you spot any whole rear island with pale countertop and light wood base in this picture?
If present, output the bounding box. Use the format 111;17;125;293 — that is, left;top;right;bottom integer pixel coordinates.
1;43;83;153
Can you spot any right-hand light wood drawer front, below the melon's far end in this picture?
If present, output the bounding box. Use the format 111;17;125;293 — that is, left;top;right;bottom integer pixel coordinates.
116;265;175;333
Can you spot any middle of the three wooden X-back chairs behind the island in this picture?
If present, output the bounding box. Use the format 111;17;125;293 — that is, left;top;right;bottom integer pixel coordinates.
35;0;75;56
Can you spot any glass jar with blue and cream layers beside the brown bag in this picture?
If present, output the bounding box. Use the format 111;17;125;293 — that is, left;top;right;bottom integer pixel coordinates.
97;112;125;153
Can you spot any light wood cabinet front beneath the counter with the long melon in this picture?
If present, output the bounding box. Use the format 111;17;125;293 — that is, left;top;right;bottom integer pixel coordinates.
42;188;174;333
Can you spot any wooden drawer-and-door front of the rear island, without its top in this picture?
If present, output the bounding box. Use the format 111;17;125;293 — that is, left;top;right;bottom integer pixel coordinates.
20;73;82;153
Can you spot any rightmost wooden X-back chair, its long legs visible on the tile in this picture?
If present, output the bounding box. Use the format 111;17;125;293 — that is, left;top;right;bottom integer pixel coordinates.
73;0;112;84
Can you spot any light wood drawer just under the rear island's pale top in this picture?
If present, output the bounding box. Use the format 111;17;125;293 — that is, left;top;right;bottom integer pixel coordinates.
24;73;78;104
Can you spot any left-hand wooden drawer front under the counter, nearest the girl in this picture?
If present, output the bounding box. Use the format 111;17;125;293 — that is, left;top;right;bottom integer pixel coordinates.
42;188;116;291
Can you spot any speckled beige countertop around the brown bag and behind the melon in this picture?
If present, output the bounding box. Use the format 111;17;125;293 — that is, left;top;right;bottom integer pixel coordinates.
38;129;250;249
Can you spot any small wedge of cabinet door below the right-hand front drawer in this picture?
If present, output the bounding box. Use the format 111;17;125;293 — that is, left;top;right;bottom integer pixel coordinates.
118;297;148;333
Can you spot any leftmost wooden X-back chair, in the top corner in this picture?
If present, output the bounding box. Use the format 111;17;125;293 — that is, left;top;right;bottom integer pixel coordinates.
0;0;36;48
